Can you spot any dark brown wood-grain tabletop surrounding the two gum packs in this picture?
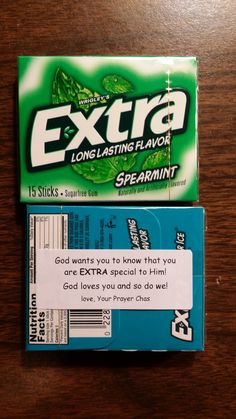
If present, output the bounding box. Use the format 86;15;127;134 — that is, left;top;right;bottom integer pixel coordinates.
0;0;236;419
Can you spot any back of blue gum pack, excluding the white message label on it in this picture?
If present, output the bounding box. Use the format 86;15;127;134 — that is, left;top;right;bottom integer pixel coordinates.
26;205;204;351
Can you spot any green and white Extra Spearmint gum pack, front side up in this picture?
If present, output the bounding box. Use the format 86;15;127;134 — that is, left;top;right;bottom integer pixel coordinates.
19;56;198;203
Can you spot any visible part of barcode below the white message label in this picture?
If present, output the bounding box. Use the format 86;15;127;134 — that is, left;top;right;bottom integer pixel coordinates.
69;310;111;337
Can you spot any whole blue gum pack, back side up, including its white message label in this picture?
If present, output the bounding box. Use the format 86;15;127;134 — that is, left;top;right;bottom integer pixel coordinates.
26;205;204;351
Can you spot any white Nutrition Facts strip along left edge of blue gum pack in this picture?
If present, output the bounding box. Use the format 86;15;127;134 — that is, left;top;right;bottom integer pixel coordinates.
29;214;68;344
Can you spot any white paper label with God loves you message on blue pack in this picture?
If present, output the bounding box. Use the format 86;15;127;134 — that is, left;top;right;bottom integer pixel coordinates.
36;249;192;310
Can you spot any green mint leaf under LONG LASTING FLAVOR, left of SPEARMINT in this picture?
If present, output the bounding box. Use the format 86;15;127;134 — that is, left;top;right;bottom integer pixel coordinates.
72;153;137;183
